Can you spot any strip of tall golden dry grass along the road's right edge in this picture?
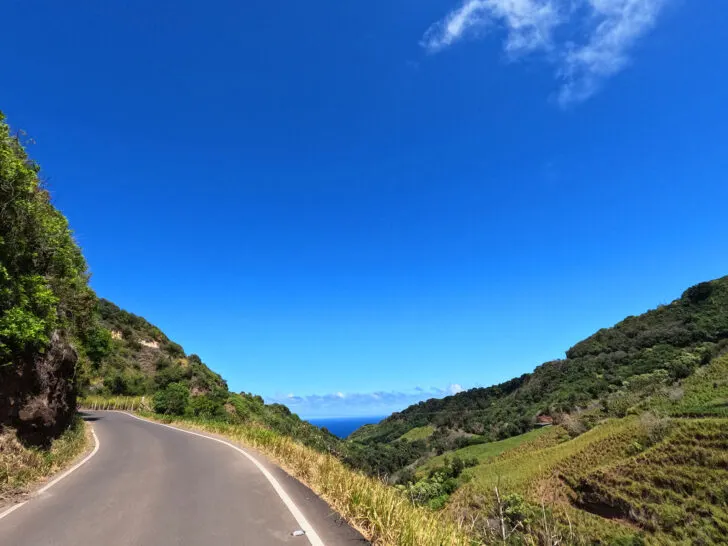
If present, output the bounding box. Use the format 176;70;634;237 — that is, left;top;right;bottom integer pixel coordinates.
142;412;479;546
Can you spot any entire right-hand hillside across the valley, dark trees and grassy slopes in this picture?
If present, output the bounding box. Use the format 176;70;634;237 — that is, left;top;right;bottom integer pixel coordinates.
347;277;728;544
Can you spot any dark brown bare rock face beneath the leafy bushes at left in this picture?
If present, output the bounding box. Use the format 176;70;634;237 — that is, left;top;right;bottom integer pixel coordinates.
0;331;78;445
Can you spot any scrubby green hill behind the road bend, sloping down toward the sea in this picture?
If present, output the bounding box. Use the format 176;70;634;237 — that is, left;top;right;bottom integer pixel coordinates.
84;299;340;451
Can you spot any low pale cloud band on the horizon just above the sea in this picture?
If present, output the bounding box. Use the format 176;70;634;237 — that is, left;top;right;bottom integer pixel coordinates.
266;383;465;417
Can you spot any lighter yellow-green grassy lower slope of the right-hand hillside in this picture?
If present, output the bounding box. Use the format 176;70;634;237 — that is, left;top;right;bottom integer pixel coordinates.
448;355;728;544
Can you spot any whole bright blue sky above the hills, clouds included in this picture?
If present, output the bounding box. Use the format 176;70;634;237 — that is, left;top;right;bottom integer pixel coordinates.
0;0;728;416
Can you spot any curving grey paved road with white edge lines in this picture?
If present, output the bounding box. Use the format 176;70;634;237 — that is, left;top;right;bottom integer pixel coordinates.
0;412;365;546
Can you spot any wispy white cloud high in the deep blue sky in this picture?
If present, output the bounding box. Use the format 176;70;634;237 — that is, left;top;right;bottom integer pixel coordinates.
421;0;670;106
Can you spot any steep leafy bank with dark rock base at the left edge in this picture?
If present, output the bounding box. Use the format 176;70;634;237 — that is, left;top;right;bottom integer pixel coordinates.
0;113;96;443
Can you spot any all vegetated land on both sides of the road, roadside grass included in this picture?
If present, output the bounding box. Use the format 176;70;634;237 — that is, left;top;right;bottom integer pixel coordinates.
0;109;728;546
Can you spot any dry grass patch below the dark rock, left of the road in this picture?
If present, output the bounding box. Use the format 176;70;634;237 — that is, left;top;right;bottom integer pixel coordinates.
0;419;91;505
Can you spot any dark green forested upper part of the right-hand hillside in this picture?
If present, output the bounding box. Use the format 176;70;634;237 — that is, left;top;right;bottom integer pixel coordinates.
351;277;728;444
